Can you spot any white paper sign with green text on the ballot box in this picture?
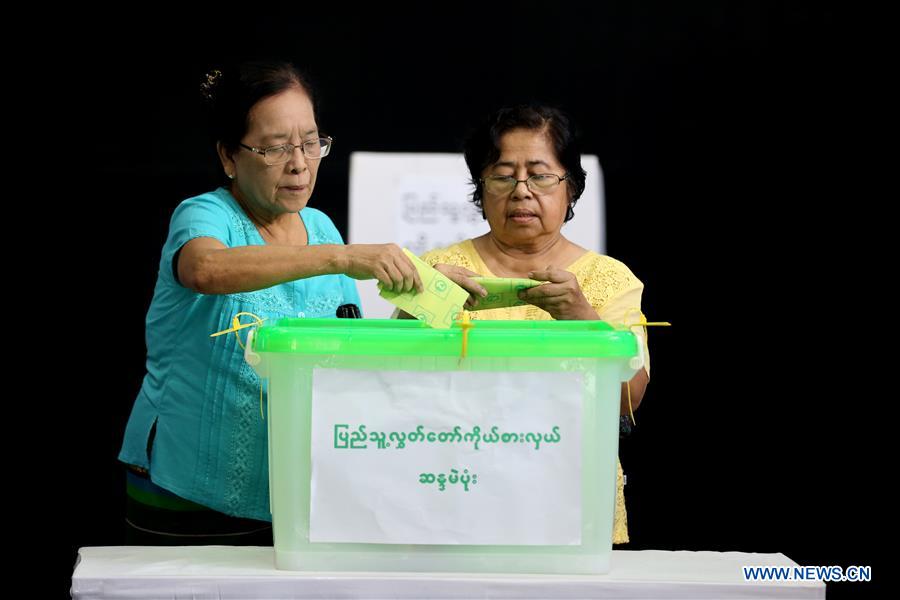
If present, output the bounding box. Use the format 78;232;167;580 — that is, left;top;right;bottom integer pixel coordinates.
309;369;583;545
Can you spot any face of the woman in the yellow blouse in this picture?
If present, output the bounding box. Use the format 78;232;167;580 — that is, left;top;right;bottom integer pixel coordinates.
481;129;569;246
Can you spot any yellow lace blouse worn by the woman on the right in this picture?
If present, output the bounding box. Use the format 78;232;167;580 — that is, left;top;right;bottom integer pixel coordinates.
422;240;650;544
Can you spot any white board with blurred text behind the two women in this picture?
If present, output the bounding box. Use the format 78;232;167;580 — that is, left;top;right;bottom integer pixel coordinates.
348;152;606;319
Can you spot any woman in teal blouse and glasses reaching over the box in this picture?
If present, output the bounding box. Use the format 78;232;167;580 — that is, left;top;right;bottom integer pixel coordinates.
119;63;421;545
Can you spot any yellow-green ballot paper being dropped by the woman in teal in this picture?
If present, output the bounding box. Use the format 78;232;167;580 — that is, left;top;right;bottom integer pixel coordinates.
378;248;469;329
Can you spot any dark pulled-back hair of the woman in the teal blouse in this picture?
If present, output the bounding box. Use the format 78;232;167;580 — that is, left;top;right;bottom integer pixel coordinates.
200;60;315;152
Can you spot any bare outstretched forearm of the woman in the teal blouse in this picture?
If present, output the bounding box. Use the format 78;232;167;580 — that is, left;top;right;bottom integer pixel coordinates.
186;245;346;294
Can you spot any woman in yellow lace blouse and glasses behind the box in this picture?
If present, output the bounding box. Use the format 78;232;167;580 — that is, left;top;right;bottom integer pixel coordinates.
422;106;649;544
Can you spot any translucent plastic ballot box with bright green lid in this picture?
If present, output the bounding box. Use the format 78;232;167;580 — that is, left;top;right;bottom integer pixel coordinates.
245;319;642;574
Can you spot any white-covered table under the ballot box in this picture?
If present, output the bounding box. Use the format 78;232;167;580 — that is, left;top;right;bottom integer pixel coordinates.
72;546;825;600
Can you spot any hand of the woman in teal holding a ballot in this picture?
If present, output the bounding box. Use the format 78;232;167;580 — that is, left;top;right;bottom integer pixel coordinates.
343;244;424;293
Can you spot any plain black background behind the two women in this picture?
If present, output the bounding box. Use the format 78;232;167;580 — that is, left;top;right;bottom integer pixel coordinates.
47;1;890;598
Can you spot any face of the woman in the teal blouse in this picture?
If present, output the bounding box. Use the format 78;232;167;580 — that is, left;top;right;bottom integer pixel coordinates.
222;88;321;217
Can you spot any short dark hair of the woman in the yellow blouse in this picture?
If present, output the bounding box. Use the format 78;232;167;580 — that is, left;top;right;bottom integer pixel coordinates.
465;104;587;221
